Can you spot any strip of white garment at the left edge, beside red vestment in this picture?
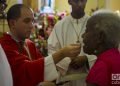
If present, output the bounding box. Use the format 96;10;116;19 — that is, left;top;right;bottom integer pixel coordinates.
0;45;13;86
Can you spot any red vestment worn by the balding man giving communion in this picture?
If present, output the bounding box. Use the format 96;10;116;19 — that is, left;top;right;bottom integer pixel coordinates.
0;34;44;86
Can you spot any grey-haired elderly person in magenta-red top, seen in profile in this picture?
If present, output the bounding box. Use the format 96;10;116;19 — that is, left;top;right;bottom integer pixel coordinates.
83;11;120;86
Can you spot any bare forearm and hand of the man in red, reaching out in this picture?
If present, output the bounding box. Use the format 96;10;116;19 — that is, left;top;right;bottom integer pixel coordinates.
52;44;81;64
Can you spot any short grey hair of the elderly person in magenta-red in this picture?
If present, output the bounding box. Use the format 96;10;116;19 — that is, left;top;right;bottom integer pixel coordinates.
88;10;120;48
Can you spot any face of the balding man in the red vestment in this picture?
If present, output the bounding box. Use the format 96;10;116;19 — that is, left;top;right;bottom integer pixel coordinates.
14;8;34;40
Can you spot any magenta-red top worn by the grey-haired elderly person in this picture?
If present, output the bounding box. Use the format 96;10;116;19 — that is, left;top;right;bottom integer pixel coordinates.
86;49;120;86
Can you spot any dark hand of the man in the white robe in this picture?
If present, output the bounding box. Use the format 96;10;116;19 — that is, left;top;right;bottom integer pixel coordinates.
70;56;88;69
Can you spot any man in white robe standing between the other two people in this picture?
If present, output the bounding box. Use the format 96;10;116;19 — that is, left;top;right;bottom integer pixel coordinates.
48;0;96;86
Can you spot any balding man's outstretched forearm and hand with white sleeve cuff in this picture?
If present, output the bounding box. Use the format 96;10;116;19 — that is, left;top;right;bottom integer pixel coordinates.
44;45;80;81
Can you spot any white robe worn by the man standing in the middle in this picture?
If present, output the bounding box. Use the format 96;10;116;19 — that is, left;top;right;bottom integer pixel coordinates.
48;15;96;86
